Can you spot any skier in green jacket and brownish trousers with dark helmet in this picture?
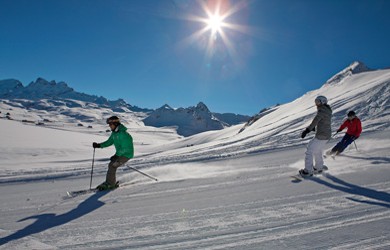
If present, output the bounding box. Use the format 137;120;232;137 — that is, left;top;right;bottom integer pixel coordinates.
92;116;134;190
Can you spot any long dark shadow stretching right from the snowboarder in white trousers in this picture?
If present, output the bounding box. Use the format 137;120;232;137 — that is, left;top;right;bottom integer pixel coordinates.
310;173;390;208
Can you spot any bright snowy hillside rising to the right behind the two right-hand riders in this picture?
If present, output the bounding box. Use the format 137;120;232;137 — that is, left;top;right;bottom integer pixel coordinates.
126;61;390;166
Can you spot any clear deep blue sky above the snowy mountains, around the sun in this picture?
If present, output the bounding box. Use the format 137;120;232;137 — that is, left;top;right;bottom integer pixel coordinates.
0;0;390;115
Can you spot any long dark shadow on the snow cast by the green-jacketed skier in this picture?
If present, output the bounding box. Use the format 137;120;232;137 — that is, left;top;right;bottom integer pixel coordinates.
0;192;108;246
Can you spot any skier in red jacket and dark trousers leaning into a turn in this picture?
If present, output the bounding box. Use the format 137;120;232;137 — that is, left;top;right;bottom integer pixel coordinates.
328;111;362;155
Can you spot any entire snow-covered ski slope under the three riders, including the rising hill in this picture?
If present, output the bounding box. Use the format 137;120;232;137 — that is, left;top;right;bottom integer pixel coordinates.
0;65;390;250
